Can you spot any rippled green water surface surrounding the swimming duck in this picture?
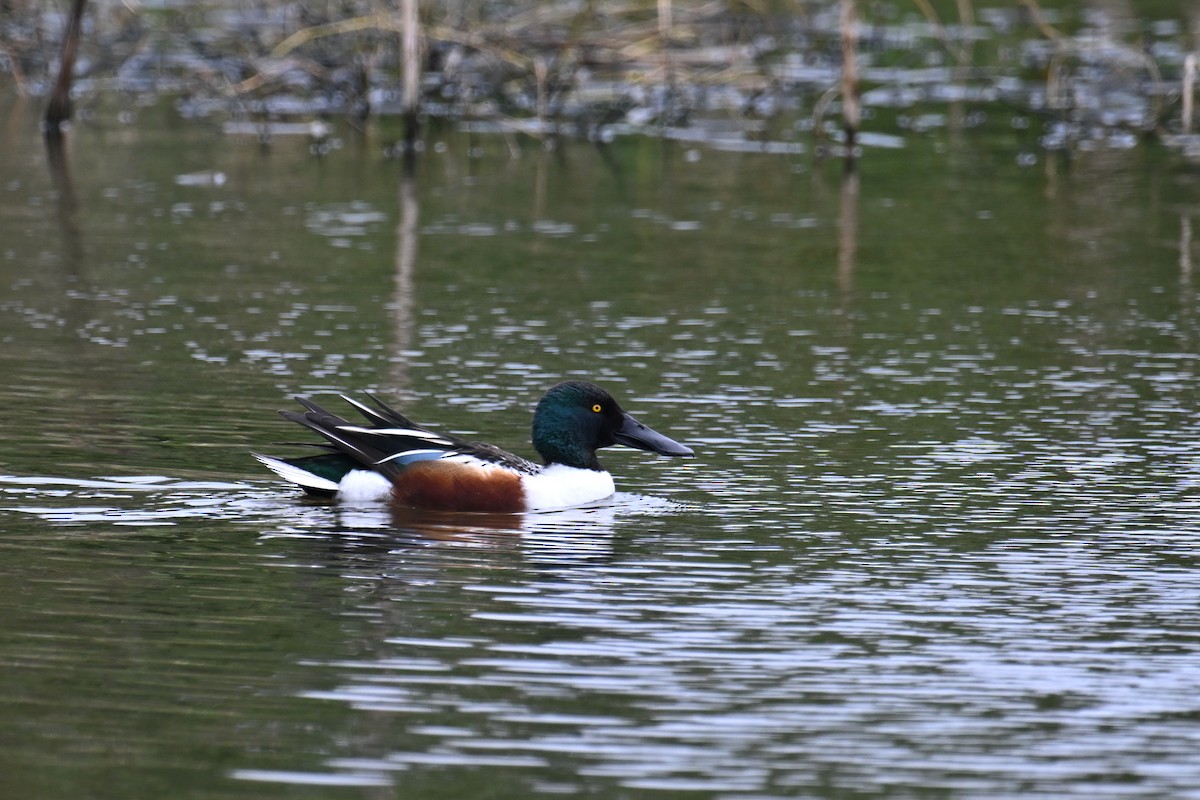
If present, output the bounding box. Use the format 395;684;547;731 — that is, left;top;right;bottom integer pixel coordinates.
0;95;1200;800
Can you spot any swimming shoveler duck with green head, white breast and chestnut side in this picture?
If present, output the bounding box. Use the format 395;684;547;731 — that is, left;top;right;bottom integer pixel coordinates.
258;380;695;513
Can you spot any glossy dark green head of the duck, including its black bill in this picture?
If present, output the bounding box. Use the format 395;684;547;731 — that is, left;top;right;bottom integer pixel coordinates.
533;380;692;469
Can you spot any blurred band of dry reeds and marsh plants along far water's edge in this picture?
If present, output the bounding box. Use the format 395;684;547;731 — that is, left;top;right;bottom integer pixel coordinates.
0;0;1200;152
